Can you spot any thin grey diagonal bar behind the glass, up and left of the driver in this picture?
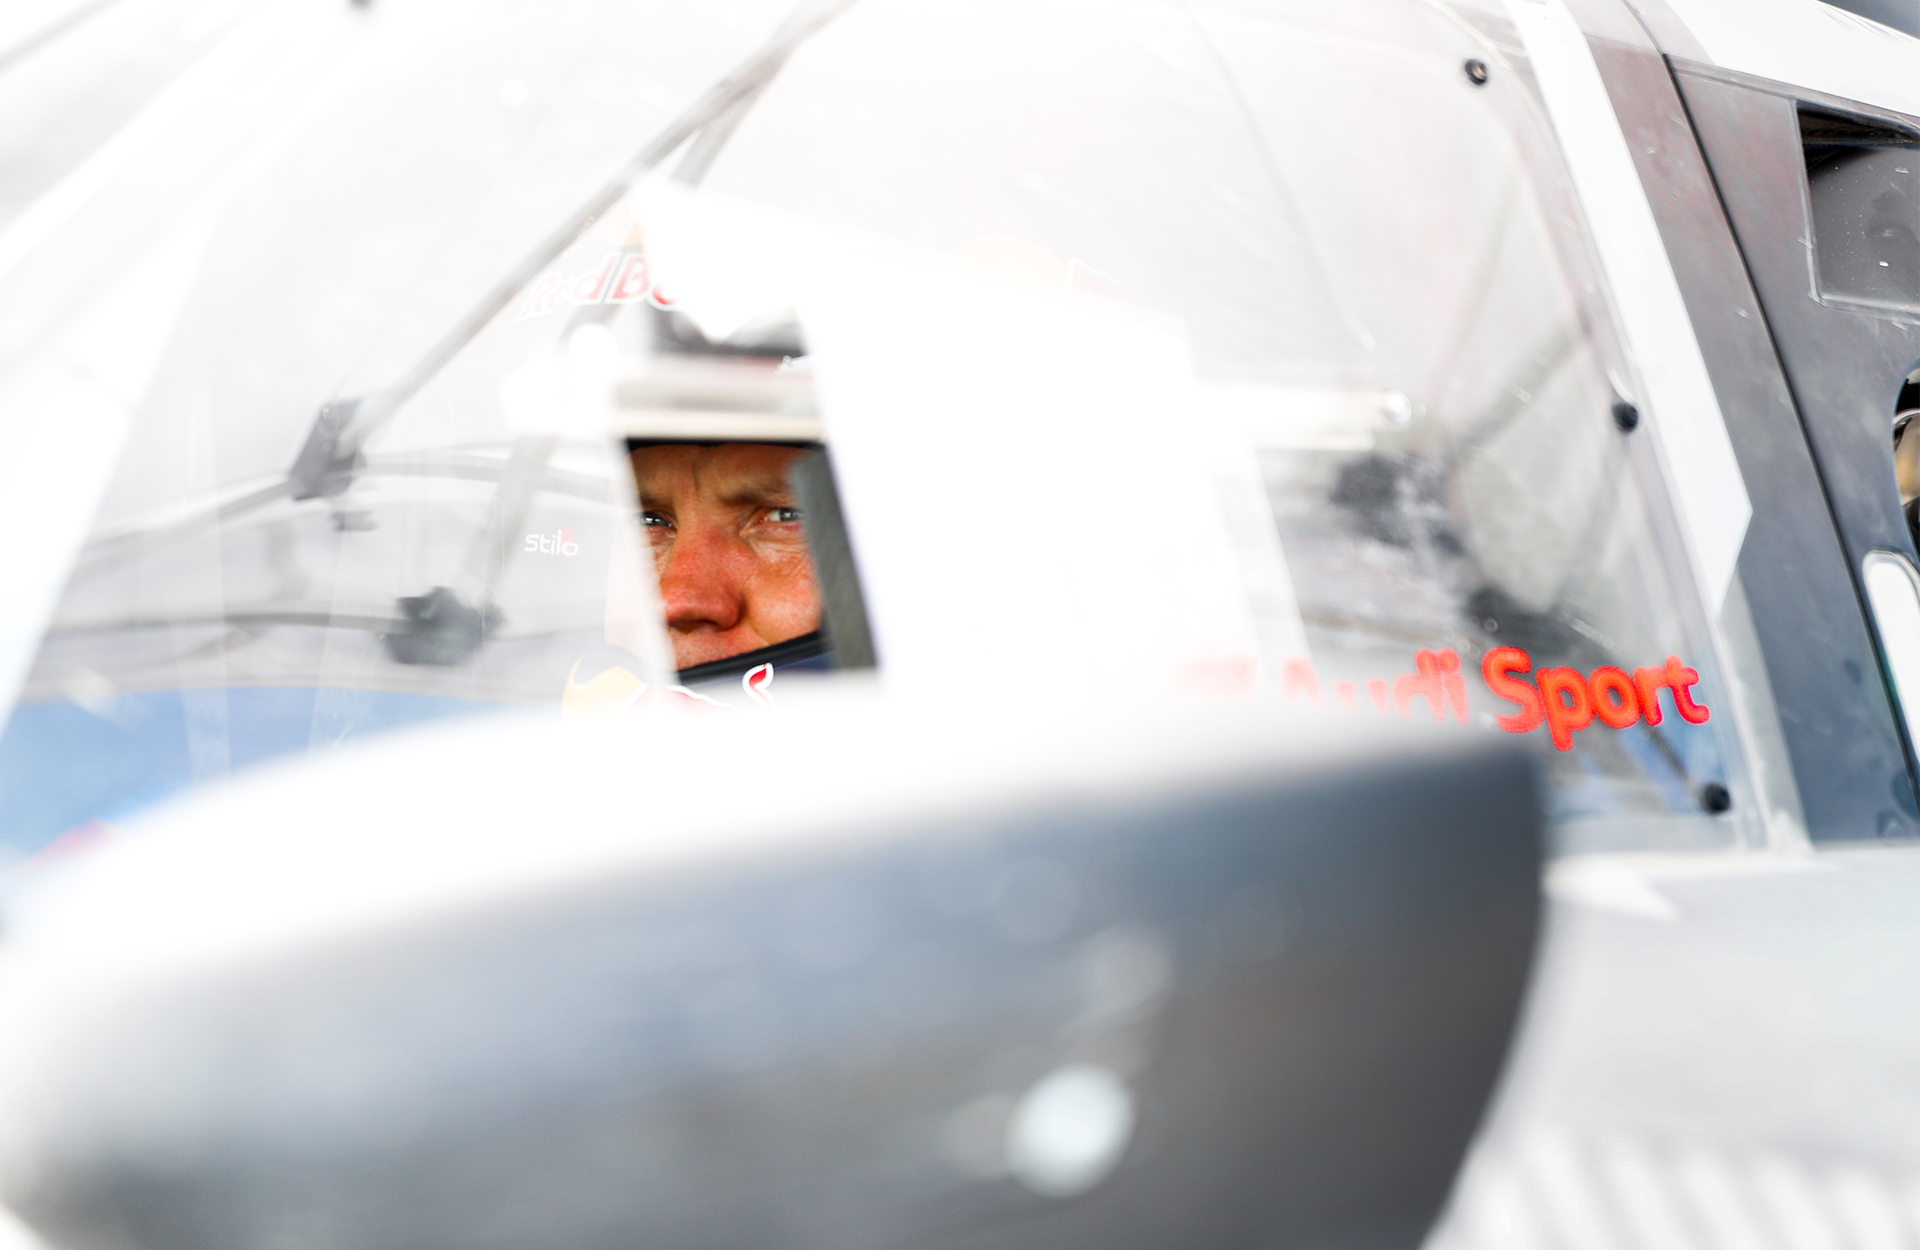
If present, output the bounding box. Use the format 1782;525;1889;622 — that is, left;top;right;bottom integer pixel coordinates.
286;0;854;499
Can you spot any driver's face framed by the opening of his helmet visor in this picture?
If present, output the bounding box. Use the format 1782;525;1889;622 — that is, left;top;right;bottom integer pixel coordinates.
634;444;820;668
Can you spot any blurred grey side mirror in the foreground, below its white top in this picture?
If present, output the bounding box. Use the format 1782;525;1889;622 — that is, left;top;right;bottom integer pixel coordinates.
0;714;1542;1250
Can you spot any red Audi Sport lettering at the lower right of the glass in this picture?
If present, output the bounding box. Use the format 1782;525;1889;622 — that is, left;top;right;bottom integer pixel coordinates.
1281;647;1711;751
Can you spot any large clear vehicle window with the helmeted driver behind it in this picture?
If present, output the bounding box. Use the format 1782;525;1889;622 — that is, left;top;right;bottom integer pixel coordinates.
0;0;1791;854
